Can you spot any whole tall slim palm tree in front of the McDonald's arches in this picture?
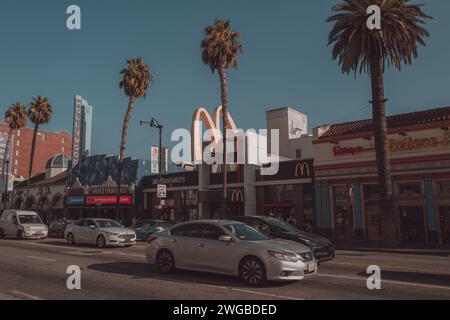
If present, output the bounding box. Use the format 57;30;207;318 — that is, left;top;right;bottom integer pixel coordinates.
201;19;243;219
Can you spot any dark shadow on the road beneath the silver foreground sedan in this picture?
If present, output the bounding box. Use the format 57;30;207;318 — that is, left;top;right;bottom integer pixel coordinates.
87;262;298;288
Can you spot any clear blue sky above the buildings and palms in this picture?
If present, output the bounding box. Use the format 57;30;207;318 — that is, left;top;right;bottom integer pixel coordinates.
0;0;450;158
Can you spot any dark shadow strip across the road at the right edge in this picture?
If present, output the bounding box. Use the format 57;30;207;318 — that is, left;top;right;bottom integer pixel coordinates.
358;270;450;288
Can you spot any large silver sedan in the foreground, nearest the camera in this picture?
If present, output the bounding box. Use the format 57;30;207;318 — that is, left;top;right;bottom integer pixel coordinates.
146;220;317;286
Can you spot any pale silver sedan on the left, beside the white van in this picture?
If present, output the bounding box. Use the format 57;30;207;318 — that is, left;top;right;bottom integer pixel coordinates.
64;219;136;248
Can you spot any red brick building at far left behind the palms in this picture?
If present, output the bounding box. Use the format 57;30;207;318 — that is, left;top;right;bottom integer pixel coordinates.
0;123;72;179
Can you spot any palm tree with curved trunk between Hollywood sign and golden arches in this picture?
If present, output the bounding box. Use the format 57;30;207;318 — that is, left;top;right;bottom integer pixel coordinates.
117;58;153;215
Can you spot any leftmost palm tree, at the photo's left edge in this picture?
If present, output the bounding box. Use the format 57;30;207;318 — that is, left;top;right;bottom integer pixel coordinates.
3;102;27;210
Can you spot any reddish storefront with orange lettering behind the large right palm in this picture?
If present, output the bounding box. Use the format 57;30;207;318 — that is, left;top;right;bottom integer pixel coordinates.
314;108;450;246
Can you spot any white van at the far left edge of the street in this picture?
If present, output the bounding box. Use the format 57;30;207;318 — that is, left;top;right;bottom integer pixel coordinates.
0;210;48;240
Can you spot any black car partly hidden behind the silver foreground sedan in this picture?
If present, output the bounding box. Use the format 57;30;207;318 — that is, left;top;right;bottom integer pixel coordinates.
233;216;335;262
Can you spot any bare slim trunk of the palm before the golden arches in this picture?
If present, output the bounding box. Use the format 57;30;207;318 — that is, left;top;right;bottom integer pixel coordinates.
219;66;228;218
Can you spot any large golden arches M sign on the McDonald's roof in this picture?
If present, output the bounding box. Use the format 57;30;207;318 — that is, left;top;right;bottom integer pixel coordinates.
191;106;237;161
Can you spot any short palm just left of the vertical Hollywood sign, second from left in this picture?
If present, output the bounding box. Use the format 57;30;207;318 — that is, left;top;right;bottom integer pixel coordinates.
27;96;53;196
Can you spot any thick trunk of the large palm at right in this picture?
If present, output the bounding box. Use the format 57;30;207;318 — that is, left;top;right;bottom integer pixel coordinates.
370;56;397;246
